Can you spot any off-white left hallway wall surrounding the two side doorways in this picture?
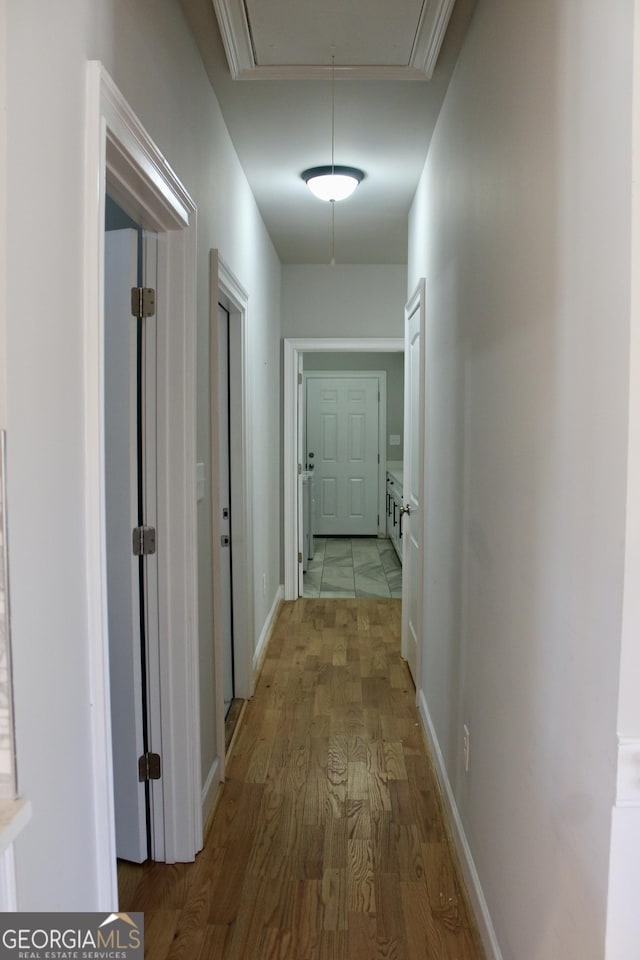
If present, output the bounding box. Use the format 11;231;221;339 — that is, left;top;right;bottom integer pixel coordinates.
7;0;280;910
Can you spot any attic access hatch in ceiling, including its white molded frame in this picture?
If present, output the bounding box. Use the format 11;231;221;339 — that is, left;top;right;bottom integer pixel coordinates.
212;0;455;80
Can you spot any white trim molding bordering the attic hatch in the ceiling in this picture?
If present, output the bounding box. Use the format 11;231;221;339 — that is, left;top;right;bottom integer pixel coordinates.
213;0;455;80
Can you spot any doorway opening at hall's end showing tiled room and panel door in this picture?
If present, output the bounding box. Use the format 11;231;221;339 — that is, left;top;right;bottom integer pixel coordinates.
301;364;404;598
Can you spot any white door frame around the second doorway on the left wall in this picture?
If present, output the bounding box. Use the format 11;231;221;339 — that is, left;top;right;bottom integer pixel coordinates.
209;250;254;794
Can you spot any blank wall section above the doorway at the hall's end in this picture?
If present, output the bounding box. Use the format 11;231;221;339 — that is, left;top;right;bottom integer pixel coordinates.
282;264;407;338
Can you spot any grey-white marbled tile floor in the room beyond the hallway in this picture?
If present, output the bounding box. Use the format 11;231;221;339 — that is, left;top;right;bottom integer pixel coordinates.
304;537;402;597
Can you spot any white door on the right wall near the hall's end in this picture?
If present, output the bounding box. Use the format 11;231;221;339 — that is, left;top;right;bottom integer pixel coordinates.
400;281;425;687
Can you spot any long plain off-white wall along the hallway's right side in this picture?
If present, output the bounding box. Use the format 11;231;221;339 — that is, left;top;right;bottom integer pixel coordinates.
409;0;637;960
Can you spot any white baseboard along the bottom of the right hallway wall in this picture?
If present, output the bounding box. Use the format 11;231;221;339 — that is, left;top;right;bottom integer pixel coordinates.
418;690;502;960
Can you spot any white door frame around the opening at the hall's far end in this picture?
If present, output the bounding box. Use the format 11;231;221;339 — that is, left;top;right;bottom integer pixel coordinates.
284;337;404;600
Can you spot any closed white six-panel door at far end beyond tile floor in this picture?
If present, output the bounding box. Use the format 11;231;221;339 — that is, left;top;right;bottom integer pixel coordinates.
306;375;380;537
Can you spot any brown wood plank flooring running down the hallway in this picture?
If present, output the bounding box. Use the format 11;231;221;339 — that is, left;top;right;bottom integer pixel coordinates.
119;599;484;960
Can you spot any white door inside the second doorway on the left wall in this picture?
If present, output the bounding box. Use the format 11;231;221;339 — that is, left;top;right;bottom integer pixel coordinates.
216;306;235;716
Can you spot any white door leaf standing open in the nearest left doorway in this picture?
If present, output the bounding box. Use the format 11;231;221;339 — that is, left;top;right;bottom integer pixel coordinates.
105;230;147;863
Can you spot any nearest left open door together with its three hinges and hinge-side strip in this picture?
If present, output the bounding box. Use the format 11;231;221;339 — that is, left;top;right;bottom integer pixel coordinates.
104;229;160;863
